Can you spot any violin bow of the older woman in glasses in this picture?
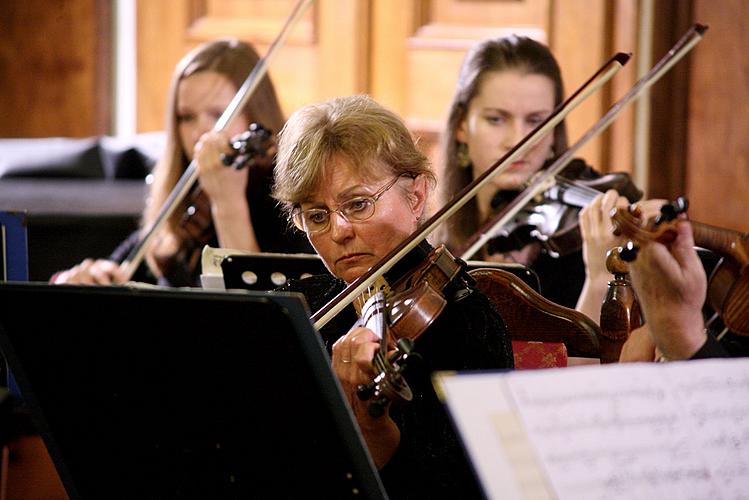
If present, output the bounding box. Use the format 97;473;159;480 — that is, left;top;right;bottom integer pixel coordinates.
310;48;630;330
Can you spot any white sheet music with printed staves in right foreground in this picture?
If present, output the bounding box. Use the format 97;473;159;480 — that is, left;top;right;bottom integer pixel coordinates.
436;359;749;500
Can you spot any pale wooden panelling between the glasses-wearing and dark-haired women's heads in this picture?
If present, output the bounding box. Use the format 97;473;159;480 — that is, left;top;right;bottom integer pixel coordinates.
370;0;549;176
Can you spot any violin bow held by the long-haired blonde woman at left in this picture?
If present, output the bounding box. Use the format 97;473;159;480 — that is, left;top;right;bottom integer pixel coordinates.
120;0;314;280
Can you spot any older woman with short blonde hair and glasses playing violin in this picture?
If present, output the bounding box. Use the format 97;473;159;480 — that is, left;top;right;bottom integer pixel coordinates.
274;96;513;498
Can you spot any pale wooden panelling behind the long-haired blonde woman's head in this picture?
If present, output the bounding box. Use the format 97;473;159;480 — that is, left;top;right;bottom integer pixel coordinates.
138;0;371;131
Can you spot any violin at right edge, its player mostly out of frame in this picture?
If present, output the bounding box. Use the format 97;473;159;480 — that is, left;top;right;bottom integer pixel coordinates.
611;197;749;336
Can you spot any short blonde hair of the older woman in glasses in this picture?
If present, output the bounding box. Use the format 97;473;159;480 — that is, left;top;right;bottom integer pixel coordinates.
273;95;436;218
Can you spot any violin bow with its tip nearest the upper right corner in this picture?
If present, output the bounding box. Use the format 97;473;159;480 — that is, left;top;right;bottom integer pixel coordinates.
456;24;707;260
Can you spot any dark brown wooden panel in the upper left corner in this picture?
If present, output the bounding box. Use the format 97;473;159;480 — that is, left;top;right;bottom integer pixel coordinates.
0;0;111;137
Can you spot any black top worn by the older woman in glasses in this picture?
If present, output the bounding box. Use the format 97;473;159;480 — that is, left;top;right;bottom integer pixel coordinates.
284;244;514;499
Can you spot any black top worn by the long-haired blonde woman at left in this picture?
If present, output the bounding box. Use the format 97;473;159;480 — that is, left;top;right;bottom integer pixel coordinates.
109;161;314;286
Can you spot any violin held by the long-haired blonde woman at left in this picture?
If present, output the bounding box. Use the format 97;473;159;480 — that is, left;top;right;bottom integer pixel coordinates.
156;123;276;281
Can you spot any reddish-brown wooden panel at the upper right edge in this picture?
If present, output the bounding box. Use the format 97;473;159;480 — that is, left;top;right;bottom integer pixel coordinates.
686;0;749;232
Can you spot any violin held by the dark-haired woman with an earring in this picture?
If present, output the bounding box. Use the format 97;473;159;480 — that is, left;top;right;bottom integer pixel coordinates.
487;159;643;258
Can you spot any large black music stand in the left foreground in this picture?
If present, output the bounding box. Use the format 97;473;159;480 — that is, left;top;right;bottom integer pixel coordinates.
0;283;385;499
